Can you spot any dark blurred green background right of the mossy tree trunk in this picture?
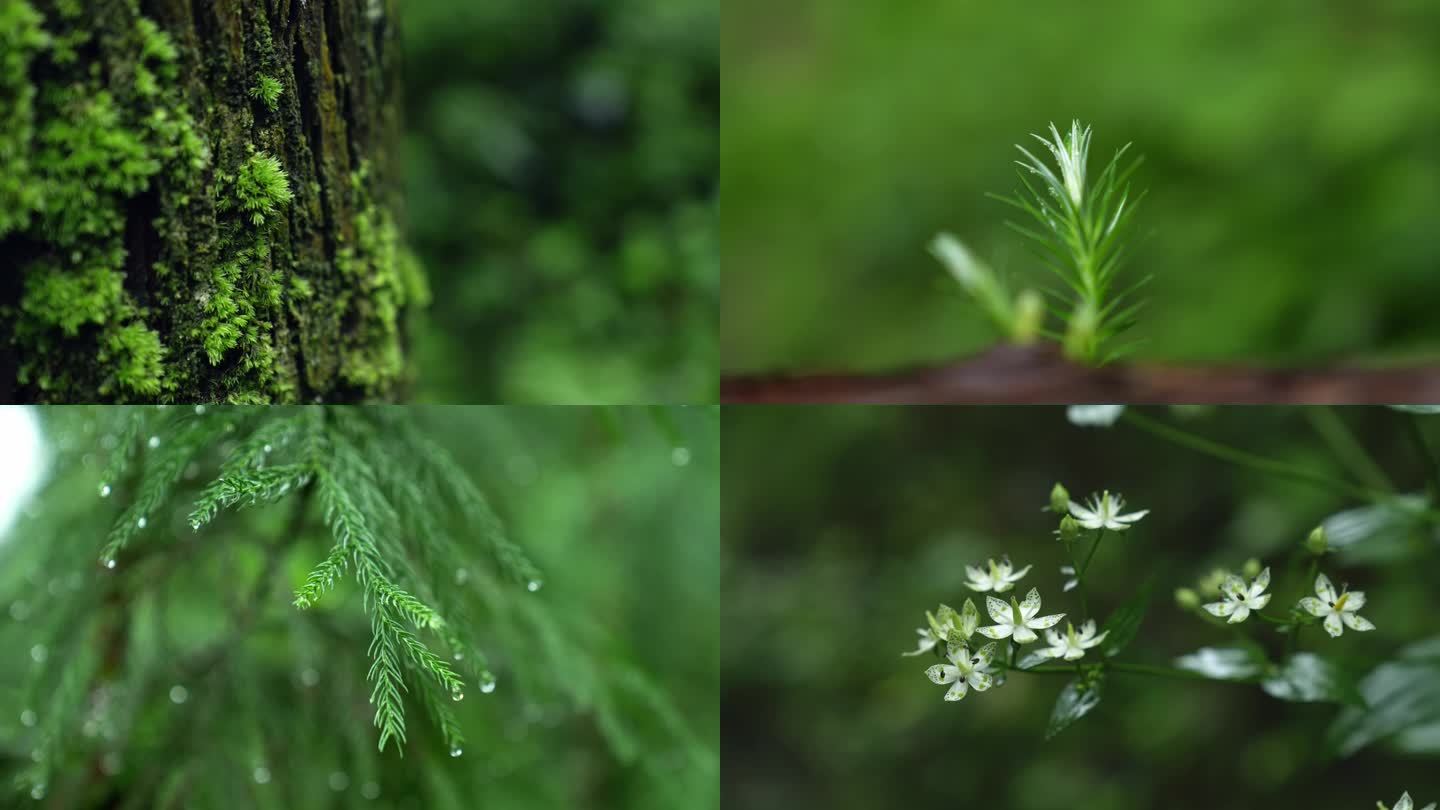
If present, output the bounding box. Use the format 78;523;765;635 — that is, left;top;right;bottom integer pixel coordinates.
402;0;720;404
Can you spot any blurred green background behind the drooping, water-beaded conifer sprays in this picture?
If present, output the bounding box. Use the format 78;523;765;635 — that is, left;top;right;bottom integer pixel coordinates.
0;406;720;810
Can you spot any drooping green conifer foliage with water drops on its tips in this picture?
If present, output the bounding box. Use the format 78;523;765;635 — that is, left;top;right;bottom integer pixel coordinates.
0;405;713;807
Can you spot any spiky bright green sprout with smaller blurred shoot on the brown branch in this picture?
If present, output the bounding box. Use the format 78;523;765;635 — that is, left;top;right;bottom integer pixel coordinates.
932;121;1148;365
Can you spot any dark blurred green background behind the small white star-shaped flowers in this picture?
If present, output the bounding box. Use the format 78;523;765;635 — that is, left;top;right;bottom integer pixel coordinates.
721;406;1440;810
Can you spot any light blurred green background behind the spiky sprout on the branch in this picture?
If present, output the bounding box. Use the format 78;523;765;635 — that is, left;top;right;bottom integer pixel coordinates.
720;0;1440;372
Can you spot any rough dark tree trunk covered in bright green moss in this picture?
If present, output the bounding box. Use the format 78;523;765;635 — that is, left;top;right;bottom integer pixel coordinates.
0;0;425;402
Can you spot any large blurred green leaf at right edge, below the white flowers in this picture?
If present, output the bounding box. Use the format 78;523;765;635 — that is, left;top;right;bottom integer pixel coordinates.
1325;637;1440;757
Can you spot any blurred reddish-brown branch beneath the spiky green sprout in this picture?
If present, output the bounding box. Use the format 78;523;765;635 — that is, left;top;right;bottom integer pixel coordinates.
720;346;1440;405
